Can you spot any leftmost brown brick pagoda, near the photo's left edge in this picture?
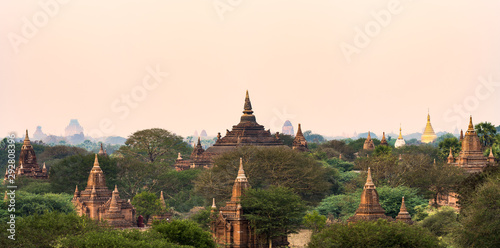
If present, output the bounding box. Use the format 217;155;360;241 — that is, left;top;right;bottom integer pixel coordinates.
5;130;49;180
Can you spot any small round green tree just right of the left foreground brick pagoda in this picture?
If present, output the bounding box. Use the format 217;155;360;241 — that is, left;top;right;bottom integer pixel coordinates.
132;191;166;223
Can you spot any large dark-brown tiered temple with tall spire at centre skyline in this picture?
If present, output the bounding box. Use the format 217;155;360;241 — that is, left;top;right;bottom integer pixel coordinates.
175;91;284;171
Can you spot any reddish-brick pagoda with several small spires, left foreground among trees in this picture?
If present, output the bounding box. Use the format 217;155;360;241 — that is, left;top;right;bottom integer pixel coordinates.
71;154;136;228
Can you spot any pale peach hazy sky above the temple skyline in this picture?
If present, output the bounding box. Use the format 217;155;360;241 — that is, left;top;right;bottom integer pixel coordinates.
0;0;500;137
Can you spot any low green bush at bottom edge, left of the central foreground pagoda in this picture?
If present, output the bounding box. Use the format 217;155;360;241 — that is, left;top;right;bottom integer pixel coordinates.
153;220;216;248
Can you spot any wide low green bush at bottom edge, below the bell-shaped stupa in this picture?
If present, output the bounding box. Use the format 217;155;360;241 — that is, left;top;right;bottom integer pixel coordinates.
309;219;442;248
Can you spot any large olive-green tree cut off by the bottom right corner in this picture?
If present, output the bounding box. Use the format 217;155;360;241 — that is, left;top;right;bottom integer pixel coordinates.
455;174;500;247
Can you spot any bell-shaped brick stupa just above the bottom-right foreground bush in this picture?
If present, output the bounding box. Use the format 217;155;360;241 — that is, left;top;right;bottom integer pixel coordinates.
347;167;393;223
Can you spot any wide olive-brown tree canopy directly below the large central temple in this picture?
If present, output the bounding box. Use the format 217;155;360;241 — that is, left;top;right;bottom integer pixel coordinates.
195;146;336;203
